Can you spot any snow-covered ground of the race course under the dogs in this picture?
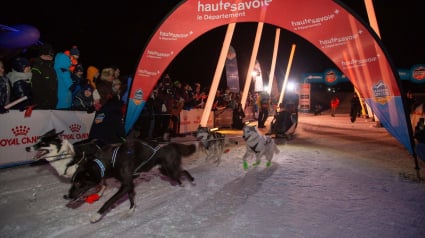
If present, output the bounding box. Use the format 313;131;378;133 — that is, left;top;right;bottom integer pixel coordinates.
0;114;425;238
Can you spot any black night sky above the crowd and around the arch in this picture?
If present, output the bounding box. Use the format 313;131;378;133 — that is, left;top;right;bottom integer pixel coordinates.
0;0;425;89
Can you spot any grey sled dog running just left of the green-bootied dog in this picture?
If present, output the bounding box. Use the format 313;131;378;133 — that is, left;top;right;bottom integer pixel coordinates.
196;126;225;165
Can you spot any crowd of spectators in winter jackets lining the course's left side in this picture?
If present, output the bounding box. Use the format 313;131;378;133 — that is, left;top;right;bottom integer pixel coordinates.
0;43;272;144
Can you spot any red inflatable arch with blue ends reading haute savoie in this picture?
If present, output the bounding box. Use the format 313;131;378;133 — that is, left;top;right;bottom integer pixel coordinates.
126;0;414;158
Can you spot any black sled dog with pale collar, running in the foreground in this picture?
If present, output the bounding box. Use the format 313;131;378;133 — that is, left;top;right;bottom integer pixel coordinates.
67;139;196;223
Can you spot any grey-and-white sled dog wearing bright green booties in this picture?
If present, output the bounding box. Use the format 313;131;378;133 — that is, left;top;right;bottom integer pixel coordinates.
242;125;280;170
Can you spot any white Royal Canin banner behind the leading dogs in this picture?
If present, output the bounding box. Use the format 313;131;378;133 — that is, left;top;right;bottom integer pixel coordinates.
0;110;95;164
